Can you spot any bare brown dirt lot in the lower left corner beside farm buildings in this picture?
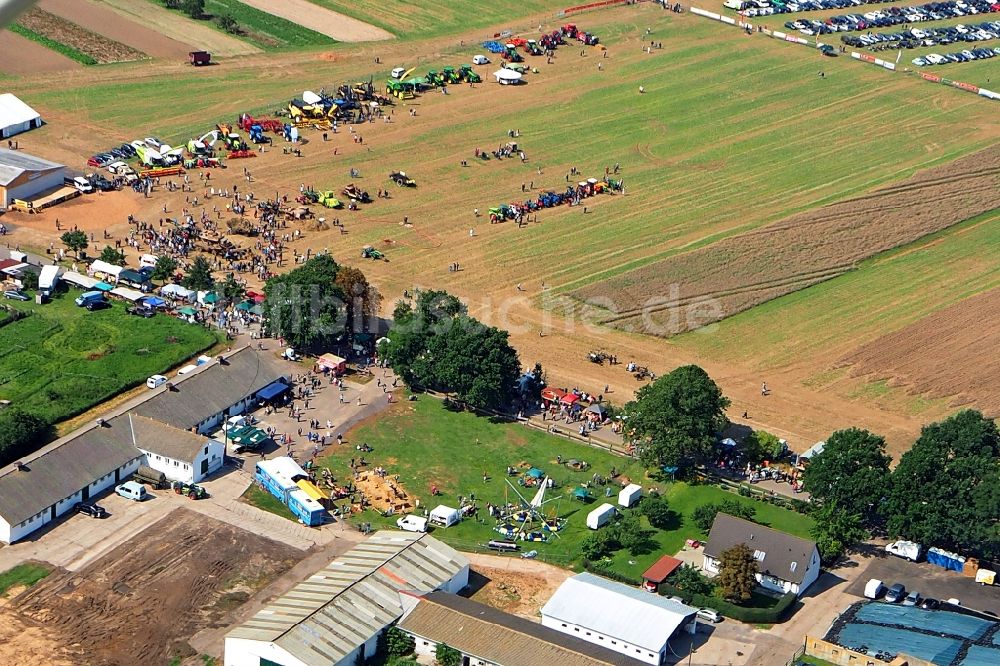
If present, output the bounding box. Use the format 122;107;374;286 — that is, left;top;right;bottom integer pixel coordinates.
0;509;302;666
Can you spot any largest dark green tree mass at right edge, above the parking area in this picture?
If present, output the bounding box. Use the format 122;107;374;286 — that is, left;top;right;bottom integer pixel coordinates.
886;410;1000;557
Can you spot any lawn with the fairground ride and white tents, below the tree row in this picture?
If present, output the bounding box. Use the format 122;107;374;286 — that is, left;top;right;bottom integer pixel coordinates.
314;396;811;574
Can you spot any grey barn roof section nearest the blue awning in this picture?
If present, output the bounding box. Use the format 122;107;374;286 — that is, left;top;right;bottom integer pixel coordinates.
134;347;290;430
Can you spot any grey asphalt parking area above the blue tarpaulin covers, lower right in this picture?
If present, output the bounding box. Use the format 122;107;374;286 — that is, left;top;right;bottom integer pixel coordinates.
847;555;1000;615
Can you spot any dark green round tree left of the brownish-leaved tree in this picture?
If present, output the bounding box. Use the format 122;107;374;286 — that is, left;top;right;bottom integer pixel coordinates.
264;254;347;349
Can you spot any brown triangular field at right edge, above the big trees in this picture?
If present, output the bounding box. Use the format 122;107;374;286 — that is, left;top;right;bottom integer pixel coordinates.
841;289;1000;417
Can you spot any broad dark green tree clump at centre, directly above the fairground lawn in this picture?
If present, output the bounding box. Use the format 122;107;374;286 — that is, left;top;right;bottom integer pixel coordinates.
381;291;521;410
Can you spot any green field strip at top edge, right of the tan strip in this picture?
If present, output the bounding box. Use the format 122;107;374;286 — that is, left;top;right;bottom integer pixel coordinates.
312;0;566;39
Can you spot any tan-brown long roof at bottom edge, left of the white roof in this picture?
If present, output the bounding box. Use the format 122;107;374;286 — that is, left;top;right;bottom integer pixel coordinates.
399;592;643;666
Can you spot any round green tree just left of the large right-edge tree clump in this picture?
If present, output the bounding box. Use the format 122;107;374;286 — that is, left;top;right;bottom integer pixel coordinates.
803;428;892;526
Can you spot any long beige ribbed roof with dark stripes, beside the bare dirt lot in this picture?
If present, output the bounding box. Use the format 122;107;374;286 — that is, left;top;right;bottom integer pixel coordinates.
226;531;469;666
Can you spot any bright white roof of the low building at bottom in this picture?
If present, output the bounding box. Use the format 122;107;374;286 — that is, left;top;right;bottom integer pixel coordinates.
542;572;695;652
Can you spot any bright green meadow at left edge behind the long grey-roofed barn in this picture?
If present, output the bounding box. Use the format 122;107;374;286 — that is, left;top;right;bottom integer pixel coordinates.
0;291;218;423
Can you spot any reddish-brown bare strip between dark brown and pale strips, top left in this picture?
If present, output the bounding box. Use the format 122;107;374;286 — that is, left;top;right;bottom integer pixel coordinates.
38;0;193;58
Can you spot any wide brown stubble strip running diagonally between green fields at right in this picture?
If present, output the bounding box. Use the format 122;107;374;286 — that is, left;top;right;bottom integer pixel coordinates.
572;146;1000;336
